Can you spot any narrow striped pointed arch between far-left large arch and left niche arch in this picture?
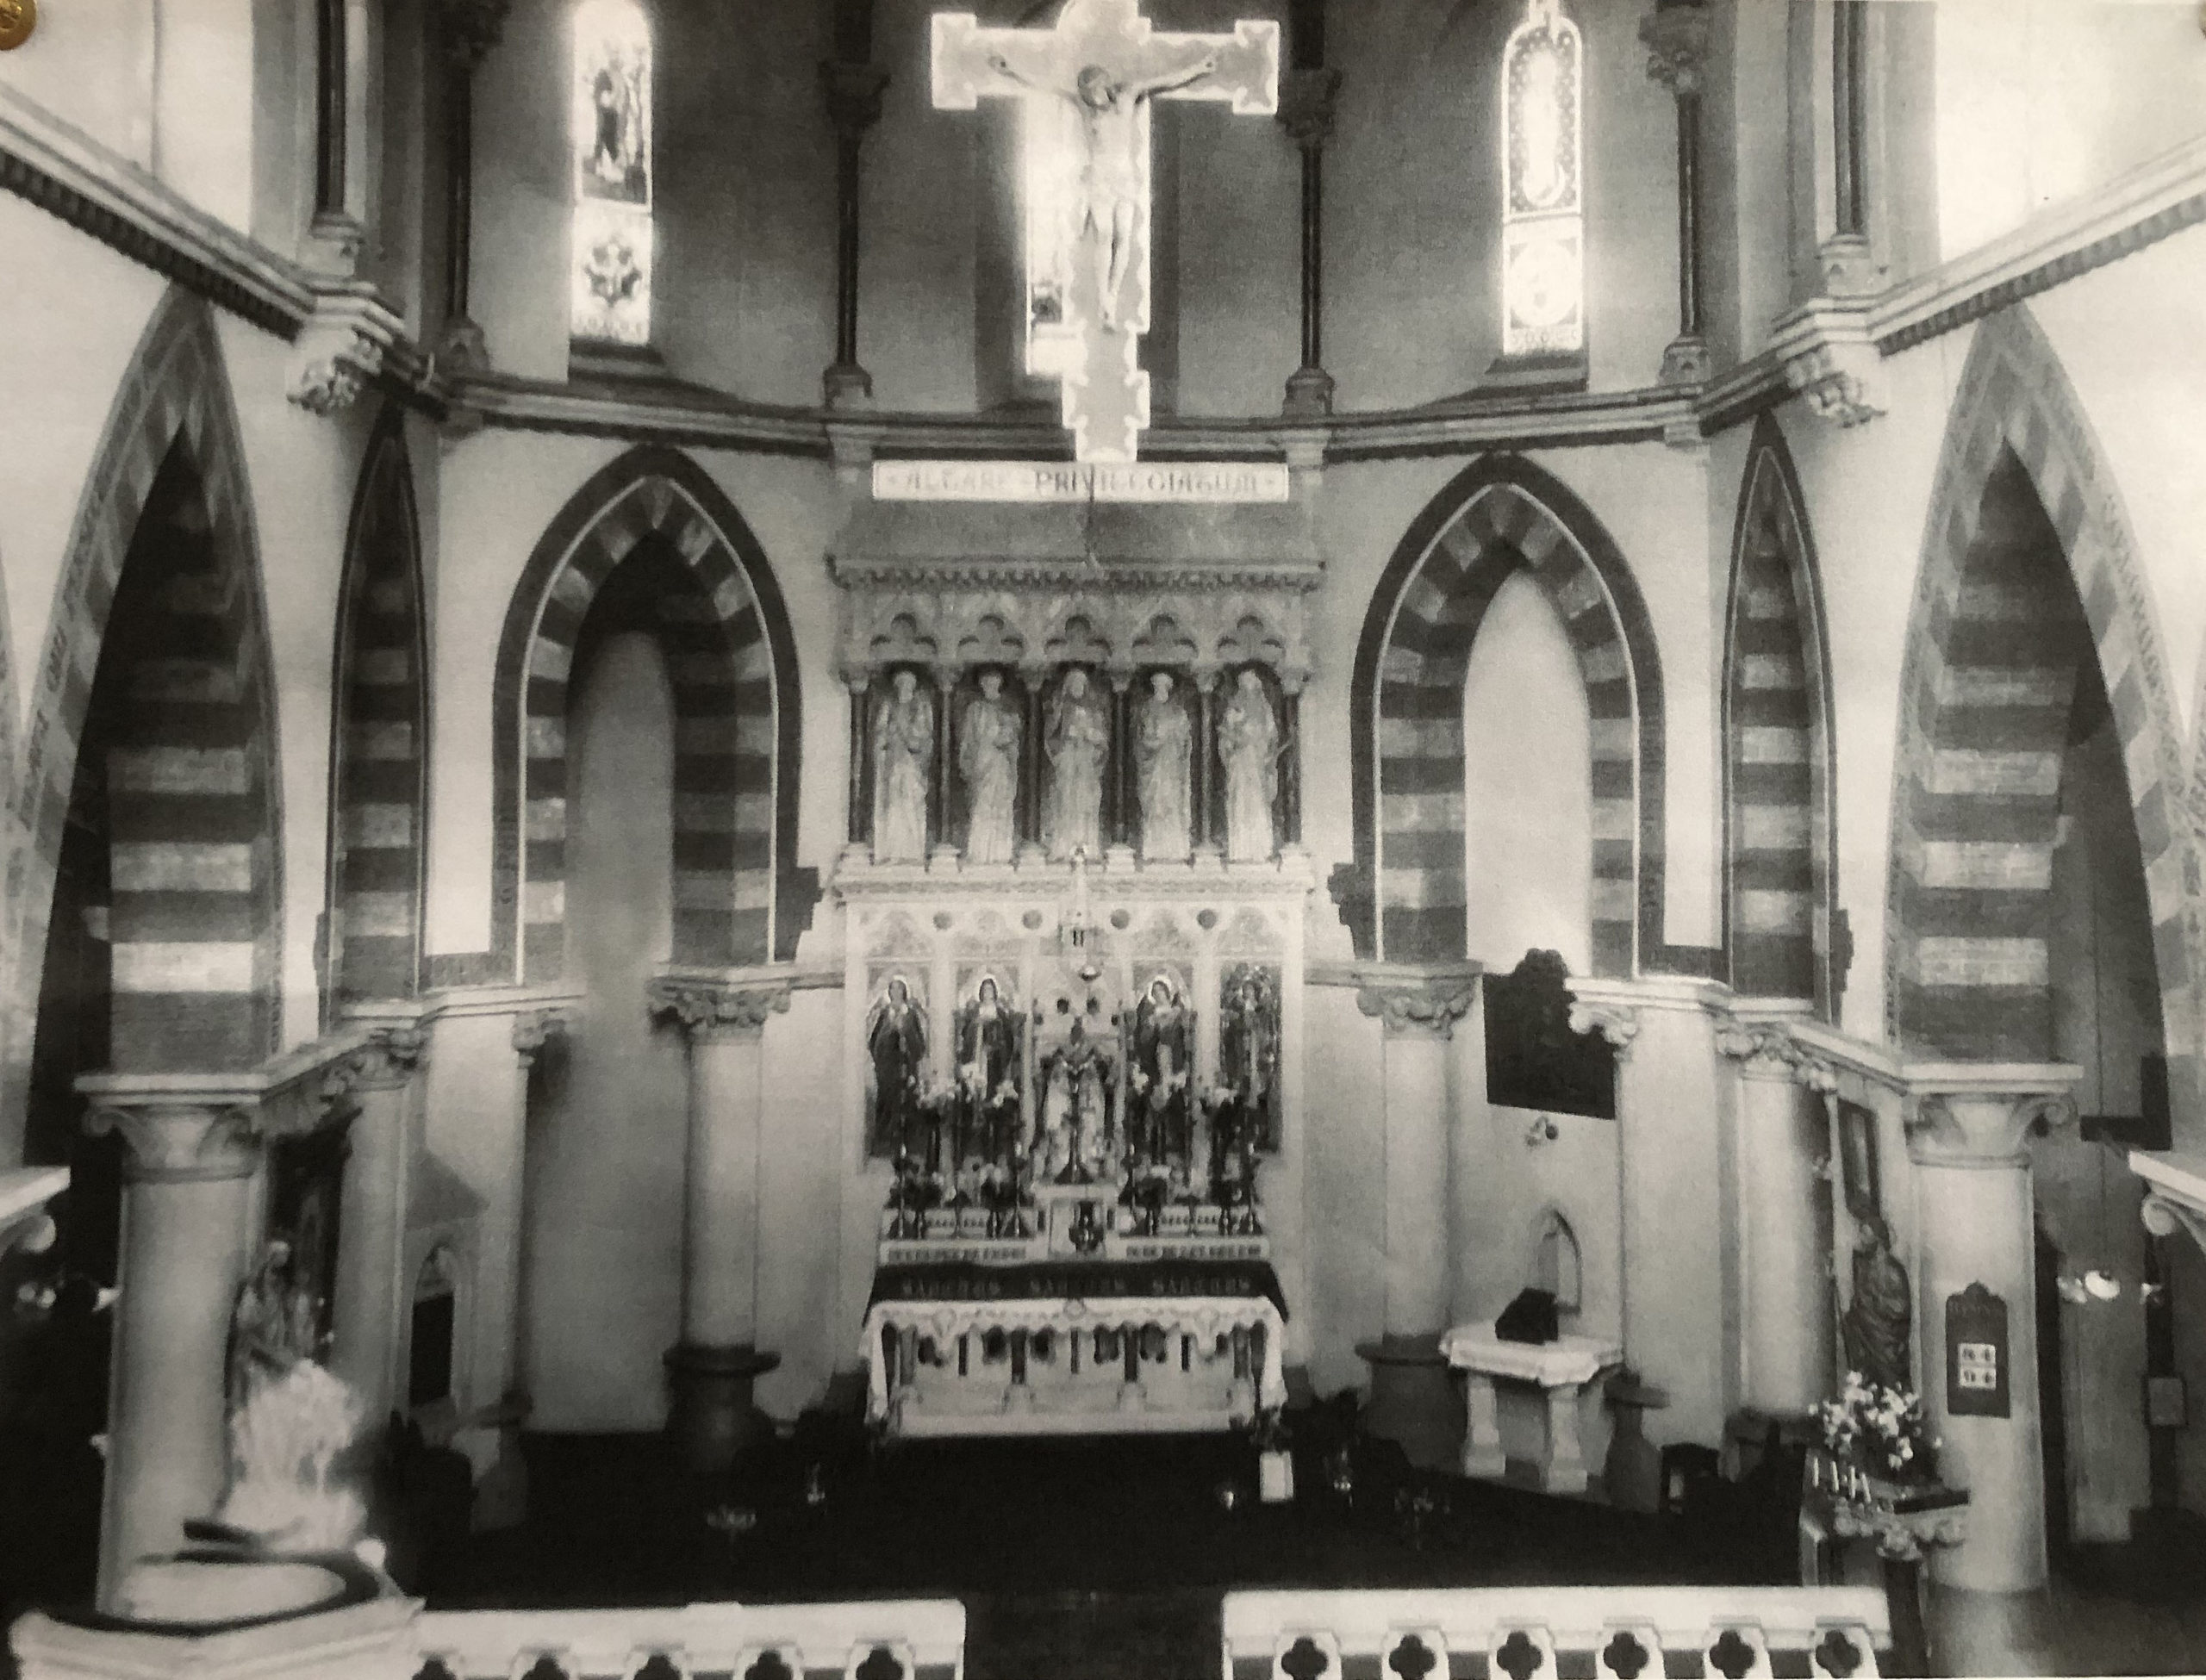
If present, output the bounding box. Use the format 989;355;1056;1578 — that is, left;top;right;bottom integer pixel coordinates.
328;403;428;1007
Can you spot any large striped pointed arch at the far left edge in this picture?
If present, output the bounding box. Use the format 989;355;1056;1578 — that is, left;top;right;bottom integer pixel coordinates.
9;289;283;1071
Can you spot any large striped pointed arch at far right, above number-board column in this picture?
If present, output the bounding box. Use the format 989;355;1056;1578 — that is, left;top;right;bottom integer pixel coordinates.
1886;304;2197;1067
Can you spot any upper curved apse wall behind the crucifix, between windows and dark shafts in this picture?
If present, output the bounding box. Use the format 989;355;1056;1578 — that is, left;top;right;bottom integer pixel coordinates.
456;0;1677;414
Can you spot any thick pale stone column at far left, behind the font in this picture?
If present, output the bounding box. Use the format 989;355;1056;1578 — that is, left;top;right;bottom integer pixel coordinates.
86;1098;263;1609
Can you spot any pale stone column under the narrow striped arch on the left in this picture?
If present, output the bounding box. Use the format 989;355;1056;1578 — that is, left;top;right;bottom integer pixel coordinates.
328;1023;428;1433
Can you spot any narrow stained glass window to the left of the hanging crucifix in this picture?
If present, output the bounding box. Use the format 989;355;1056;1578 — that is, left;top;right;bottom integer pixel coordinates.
567;0;651;348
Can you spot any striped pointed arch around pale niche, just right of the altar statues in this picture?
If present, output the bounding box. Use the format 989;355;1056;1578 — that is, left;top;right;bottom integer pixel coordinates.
1343;457;1666;974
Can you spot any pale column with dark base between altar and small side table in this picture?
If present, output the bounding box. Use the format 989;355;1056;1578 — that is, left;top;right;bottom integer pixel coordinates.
1356;963;1478;1468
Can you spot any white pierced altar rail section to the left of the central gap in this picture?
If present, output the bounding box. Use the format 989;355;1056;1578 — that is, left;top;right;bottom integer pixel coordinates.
413;1598;964;1680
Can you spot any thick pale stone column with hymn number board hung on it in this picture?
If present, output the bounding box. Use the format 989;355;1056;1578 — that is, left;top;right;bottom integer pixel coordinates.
1904;1062;2083;1592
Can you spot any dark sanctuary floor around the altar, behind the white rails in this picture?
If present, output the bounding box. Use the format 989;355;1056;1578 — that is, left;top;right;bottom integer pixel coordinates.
424;1435;2206;1680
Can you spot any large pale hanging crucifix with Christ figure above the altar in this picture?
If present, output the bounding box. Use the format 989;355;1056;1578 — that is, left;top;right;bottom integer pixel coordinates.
933;0;1280;461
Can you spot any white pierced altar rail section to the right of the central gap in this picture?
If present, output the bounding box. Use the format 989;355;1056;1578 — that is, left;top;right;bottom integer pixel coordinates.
1225;1588;1892;1680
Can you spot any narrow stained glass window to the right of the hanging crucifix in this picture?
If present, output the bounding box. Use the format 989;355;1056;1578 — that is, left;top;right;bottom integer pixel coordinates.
1502;0;1586;359
